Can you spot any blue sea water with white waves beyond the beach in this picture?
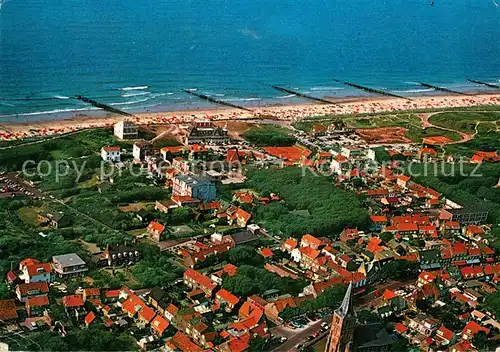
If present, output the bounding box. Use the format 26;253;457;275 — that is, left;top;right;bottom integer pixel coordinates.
0;0;500;121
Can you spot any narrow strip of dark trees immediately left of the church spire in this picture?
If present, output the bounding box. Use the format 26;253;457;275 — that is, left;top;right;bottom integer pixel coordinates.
280;285;346;320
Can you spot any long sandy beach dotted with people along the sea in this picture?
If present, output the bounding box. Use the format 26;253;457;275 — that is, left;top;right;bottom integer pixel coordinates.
0;93;500;140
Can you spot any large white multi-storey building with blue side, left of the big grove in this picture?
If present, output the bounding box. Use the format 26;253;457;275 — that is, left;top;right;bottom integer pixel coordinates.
172;175;216;202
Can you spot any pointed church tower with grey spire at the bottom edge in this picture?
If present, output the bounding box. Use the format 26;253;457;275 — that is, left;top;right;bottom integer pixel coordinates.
325;282;356;352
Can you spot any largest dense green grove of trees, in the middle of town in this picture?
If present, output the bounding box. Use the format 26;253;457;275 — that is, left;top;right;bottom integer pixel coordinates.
245;168;369;237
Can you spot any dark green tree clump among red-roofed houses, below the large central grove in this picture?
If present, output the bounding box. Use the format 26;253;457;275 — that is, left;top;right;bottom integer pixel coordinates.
222;265;306;297
